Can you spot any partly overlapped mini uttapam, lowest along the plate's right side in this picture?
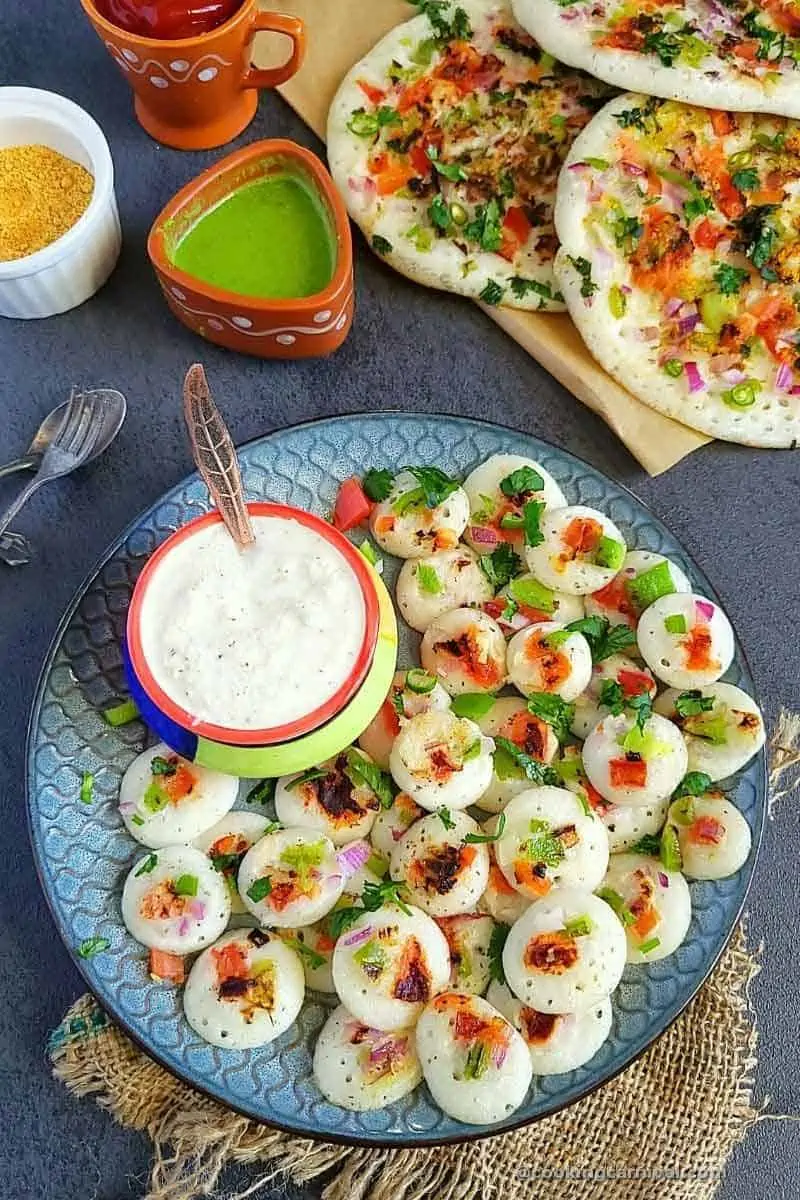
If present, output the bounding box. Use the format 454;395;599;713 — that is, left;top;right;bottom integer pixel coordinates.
597;854;692;962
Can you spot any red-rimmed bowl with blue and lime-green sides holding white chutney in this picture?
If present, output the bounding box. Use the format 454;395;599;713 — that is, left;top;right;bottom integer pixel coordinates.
122;502;397;778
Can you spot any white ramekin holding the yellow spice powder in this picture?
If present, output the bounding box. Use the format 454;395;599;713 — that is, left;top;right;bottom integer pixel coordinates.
0;88;122;318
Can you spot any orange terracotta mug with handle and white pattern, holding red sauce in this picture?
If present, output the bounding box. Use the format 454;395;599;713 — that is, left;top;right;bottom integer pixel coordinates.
80;0;306;150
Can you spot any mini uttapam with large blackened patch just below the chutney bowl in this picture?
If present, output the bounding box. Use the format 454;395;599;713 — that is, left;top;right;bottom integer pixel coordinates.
275;746;380;846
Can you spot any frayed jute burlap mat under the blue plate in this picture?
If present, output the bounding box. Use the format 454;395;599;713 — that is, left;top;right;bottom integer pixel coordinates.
48;714;800;1200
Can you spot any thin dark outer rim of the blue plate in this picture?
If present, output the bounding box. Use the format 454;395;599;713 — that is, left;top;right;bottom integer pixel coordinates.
25;408;769;1150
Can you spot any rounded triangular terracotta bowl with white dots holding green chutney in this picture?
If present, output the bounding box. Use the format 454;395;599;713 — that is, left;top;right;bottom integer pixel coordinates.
148;138;353;359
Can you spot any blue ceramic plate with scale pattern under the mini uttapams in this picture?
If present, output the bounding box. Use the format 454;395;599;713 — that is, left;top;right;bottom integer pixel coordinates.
28;413;766;1146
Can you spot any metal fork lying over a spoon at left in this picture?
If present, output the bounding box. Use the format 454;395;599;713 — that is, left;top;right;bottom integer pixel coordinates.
0;390;125;560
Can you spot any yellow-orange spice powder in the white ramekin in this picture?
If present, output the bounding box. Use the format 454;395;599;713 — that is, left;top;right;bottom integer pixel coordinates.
0;145;95;263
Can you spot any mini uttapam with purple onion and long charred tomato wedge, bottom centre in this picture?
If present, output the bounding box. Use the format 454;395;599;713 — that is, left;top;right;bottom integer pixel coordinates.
333;904;450;1030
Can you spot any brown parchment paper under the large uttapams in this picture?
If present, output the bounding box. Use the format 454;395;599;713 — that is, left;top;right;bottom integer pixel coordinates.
260;0;710;475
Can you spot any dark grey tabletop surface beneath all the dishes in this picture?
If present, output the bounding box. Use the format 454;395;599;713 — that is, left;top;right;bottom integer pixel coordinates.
0;0;800;1200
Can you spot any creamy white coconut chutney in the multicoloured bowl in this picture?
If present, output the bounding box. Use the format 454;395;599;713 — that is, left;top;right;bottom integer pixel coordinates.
140;515;366;730
